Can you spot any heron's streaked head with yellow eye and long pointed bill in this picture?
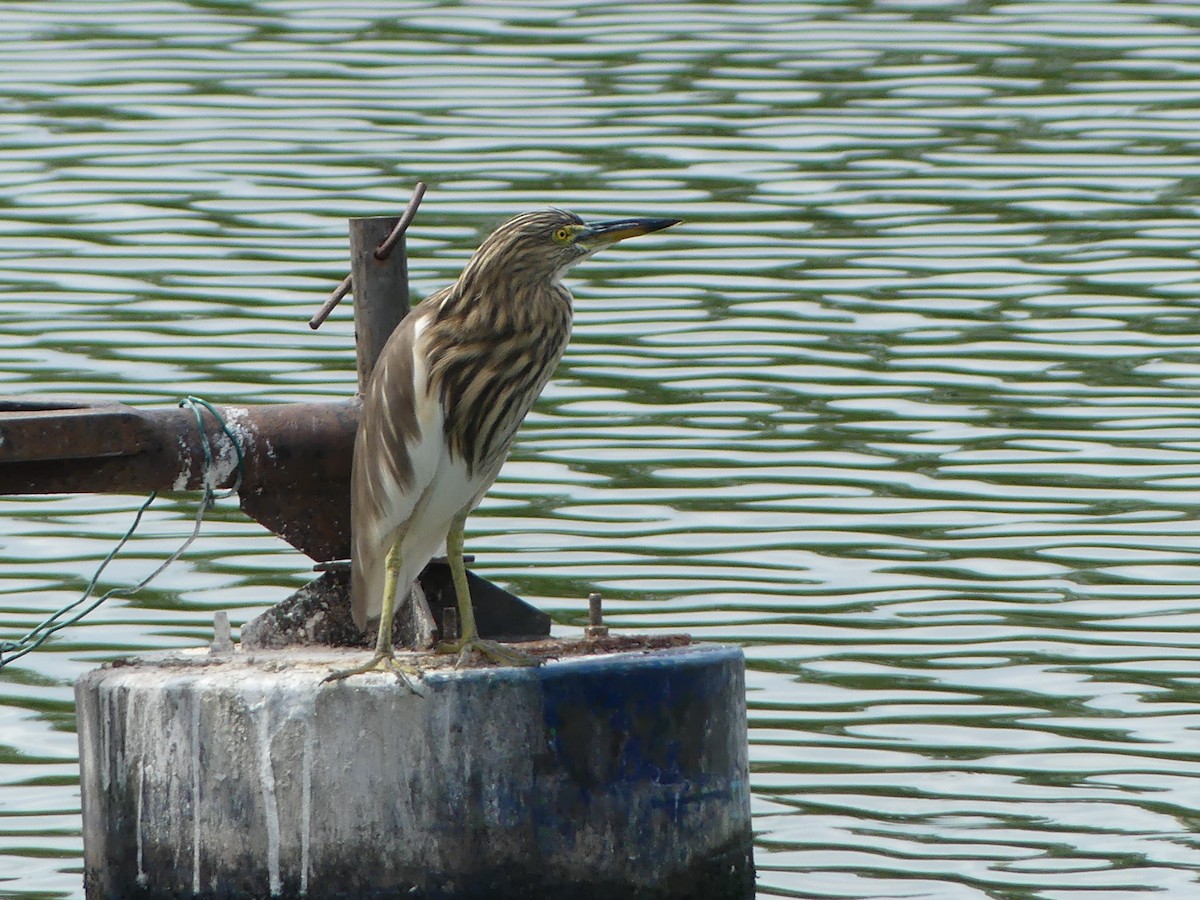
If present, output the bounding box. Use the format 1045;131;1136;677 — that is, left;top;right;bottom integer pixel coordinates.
472;209;679;280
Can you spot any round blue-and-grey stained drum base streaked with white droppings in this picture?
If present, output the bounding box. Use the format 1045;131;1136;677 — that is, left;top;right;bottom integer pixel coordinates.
76;644;754;900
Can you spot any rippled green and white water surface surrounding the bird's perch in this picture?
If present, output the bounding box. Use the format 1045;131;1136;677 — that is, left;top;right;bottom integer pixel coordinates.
0;0;1200;900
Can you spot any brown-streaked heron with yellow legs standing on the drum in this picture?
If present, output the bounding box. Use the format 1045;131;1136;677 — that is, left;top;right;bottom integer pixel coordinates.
325;209;679;680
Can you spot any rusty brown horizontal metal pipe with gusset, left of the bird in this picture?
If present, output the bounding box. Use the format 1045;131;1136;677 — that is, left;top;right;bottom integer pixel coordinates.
0;397;359;562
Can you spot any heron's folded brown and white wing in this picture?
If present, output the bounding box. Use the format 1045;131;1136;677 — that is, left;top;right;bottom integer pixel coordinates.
350;301;443;628
